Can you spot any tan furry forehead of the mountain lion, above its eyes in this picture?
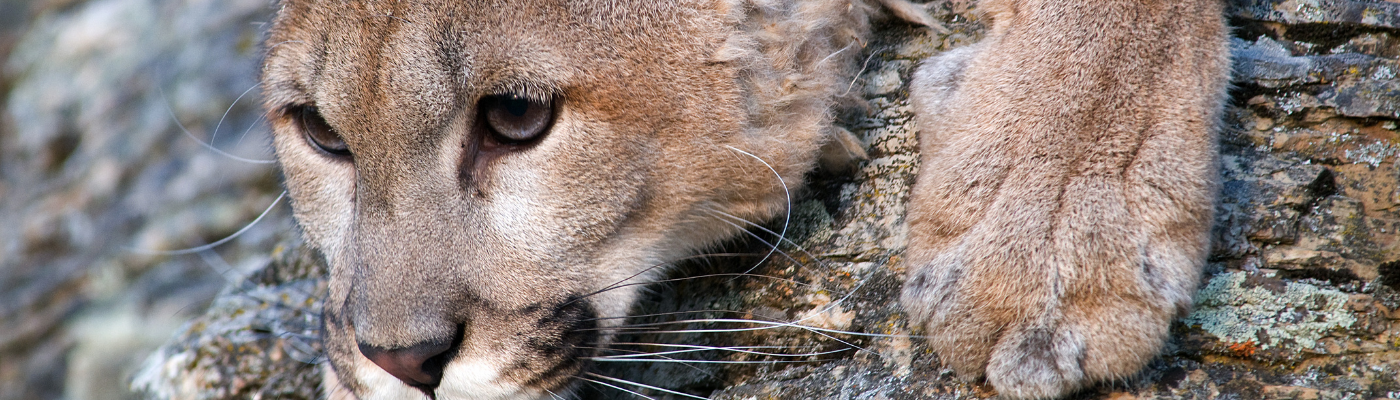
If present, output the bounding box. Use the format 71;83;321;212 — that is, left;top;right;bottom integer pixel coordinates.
265;0;718;118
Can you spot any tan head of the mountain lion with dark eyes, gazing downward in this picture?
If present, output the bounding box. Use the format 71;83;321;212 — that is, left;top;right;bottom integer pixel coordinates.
263;0;851;399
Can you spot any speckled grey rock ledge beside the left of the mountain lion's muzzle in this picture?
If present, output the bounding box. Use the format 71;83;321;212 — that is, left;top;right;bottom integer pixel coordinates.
132;241;326;400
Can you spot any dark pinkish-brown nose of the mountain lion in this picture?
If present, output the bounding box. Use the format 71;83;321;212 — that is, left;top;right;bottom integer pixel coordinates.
360;338;454;390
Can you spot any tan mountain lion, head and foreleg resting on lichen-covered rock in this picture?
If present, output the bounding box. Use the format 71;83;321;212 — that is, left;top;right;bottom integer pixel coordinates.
263;0;1229;399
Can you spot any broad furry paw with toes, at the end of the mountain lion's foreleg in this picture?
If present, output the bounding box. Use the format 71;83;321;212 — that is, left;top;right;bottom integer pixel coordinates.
902;220;1198;399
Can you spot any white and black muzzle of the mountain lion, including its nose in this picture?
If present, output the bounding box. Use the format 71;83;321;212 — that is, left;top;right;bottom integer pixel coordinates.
336;292;606;400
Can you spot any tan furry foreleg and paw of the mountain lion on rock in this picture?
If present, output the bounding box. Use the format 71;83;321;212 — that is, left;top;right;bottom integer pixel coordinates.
903;0;1229;397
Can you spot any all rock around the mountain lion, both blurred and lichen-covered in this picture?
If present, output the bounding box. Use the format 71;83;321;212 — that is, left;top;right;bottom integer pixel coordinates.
0;0;1400;400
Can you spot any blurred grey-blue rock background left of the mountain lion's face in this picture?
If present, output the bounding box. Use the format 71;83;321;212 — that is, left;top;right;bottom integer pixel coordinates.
0;0;293;400
